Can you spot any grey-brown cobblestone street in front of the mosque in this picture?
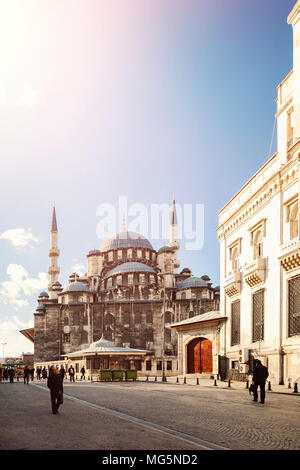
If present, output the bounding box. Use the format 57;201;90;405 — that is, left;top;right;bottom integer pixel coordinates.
0;381;300;450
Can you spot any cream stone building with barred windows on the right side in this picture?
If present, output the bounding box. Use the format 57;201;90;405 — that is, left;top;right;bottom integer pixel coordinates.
217;1;300;384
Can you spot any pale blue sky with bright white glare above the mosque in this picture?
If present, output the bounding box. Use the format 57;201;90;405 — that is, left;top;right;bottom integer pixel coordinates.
0;0;296;356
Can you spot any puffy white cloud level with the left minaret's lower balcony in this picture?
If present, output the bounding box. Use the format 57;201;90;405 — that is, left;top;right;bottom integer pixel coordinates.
0;264;48;308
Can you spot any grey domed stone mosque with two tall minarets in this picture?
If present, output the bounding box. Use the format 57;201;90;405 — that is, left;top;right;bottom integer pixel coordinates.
34;201;219;375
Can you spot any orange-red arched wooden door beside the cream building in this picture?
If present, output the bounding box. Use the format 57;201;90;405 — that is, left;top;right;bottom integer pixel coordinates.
187;338;213;374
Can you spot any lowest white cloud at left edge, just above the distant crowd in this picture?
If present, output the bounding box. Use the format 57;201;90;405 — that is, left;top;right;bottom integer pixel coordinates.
0;316;33;357
